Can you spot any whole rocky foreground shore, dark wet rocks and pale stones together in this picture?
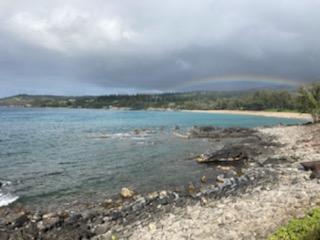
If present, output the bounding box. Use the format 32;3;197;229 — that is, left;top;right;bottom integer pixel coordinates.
0;125;320;240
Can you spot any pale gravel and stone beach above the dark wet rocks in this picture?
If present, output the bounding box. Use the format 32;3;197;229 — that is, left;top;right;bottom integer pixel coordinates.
97;124;320;240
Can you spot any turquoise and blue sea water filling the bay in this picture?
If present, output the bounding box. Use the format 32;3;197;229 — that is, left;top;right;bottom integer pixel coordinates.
0;108;301;205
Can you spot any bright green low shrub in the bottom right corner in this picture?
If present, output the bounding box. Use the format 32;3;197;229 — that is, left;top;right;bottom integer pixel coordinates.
268;208;320;240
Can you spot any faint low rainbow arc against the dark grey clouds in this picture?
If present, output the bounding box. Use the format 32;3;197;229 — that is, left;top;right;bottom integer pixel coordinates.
173;75;301;89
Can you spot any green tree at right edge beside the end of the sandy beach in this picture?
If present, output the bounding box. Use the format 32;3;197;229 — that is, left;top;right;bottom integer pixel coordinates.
299;82;320;122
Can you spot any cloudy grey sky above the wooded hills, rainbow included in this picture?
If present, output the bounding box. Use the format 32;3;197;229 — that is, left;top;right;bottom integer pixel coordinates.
0;0;320;97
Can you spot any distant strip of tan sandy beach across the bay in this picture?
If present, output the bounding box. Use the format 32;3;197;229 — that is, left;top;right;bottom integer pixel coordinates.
183;110;312;121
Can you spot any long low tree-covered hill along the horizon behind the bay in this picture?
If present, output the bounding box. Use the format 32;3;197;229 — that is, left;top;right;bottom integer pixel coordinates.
0;90;299;111
